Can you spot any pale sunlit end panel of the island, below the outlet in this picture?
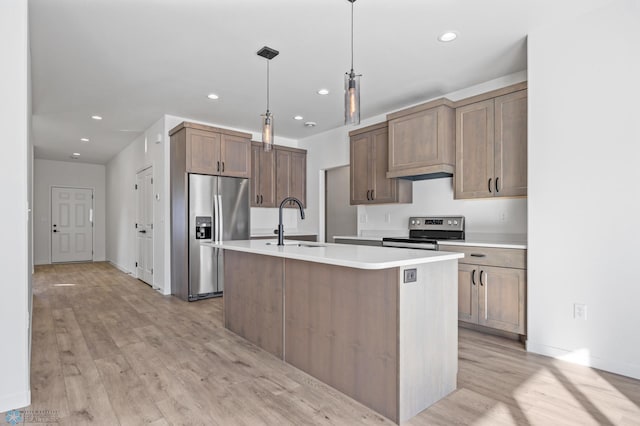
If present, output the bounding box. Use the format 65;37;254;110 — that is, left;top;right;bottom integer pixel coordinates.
394;260;458;423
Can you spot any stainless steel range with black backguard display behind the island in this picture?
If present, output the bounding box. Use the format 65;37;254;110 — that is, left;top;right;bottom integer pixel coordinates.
382;216;464;250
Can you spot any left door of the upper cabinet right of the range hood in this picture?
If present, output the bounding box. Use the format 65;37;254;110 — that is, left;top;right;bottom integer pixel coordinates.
455;99;495;198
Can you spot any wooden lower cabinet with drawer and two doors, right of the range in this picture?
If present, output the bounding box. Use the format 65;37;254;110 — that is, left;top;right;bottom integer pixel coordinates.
440;245;527;335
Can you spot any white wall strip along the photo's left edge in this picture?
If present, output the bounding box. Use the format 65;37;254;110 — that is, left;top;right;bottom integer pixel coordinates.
0;0;31;412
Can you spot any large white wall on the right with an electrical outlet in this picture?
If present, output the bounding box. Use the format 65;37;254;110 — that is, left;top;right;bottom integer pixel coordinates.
527;0;640;378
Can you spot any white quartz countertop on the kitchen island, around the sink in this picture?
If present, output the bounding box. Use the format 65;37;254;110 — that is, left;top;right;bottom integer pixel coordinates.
208;239;464;269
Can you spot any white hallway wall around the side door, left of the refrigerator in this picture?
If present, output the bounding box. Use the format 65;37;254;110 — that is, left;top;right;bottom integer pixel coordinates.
106;118;165;294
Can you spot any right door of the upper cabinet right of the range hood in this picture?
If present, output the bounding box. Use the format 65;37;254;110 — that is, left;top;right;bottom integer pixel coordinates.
494;90;527;197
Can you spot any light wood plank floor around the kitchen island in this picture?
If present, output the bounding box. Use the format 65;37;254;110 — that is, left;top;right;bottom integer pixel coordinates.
10;263;640;425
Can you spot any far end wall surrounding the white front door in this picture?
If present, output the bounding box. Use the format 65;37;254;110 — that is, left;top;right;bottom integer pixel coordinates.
33;159;106;265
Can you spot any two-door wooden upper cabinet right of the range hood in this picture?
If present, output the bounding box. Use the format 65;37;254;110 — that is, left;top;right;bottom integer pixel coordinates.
455;83;527;199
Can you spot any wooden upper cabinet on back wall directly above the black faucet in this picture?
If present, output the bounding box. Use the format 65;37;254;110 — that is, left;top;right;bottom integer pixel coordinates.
275;146;307;208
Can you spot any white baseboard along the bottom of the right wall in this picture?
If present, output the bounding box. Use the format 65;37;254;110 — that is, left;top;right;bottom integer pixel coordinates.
527;340;640;379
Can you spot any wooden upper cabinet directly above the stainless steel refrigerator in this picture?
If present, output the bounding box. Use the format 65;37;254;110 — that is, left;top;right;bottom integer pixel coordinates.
169;122;251;178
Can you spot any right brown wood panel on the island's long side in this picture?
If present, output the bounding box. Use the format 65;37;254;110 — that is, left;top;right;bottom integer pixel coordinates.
285;259;399;421
